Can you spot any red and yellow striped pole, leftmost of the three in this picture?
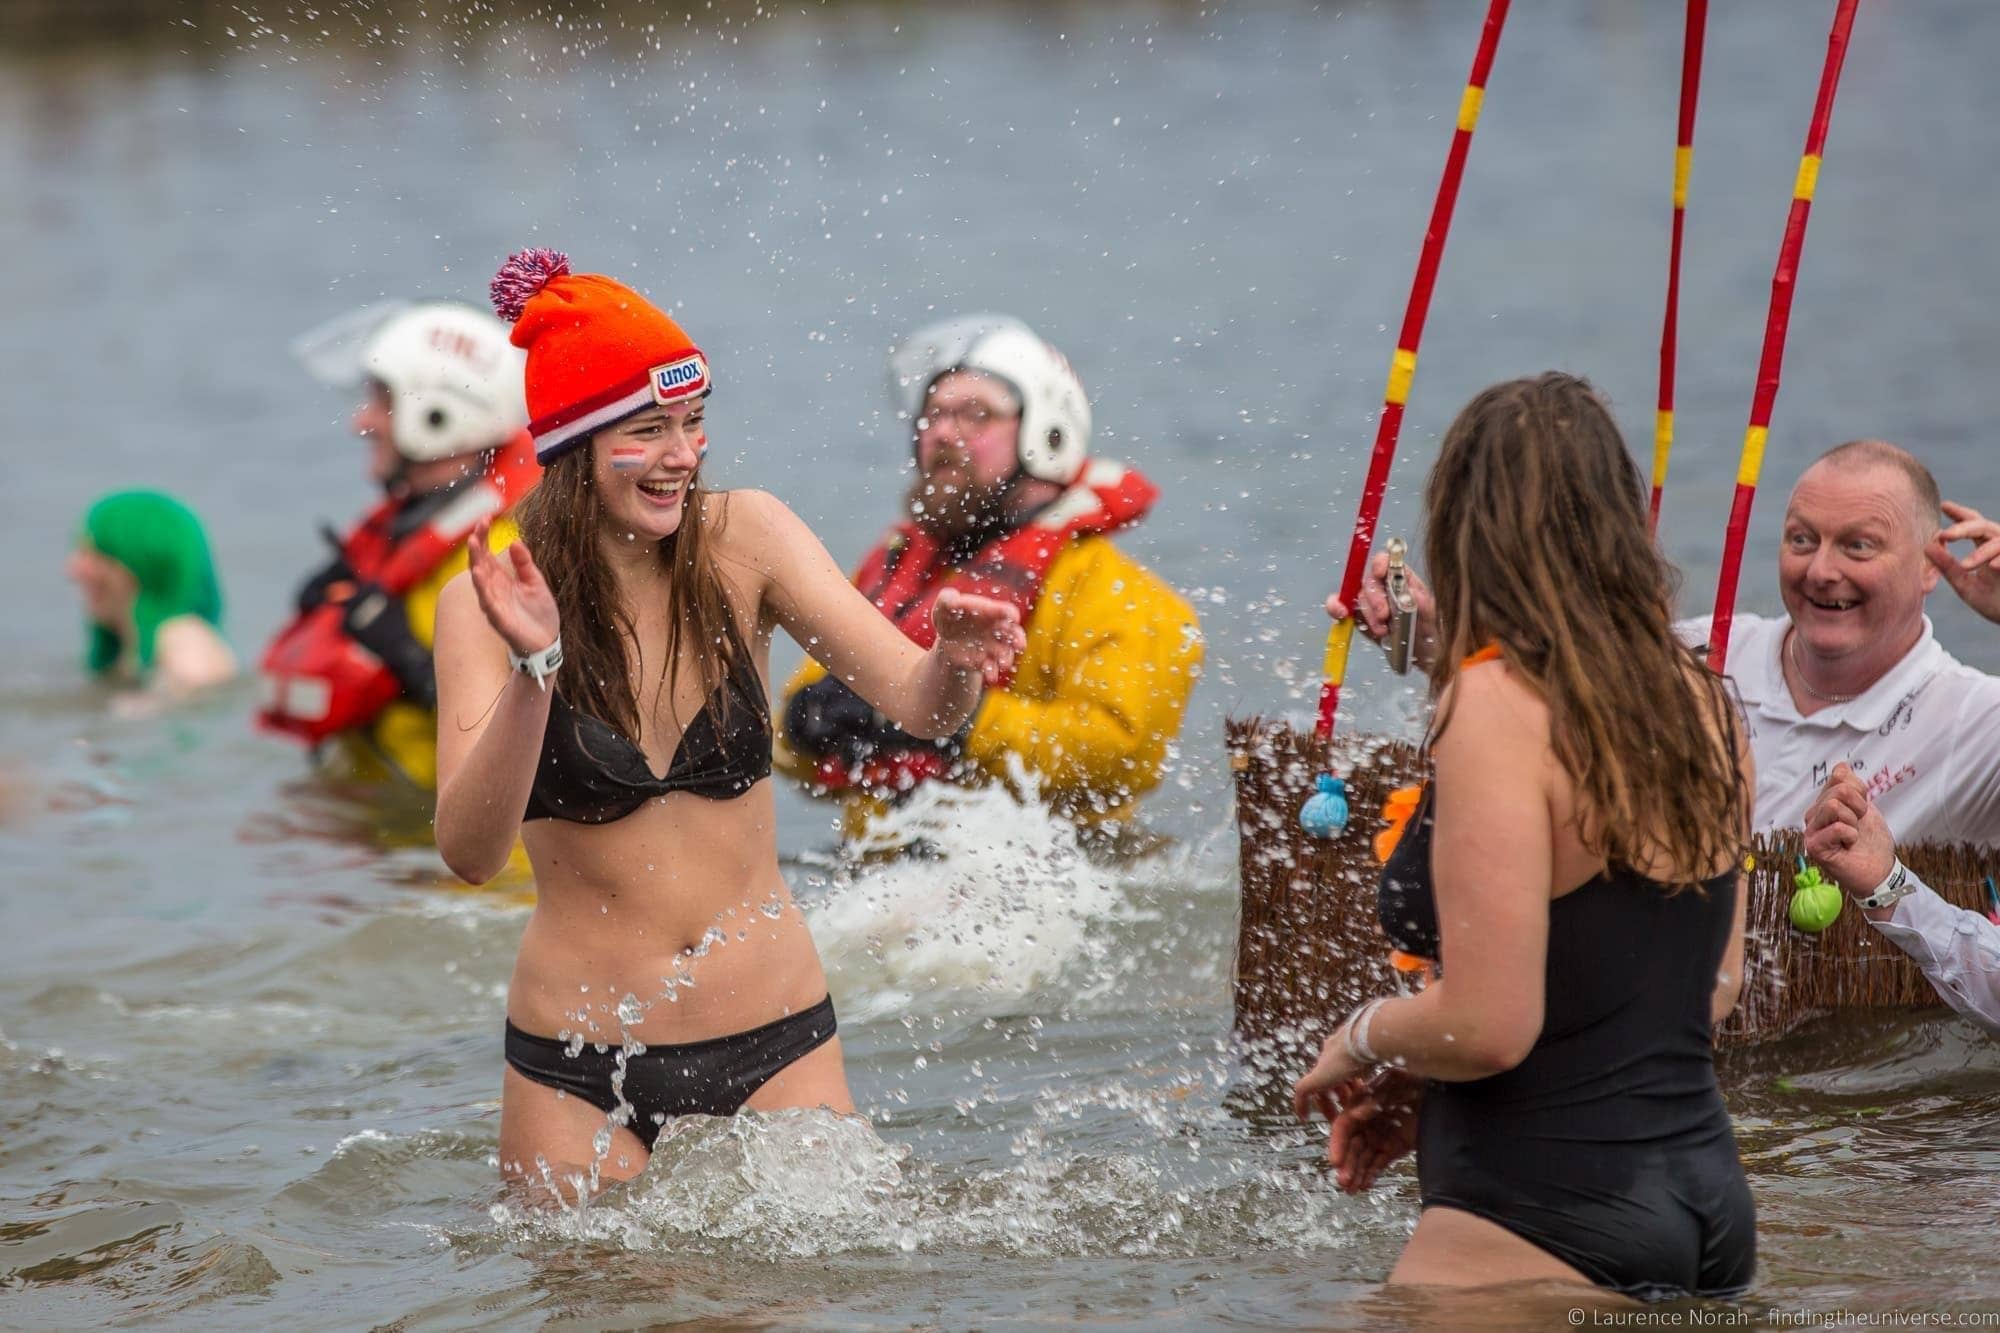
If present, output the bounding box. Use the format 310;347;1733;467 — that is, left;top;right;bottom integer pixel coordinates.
1316;0;1508;739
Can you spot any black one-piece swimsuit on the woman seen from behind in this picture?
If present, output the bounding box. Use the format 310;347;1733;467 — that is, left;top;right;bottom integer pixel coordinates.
1378;793;1756;1299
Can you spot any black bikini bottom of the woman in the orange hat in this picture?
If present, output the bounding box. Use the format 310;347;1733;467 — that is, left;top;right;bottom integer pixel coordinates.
506;995;836;1151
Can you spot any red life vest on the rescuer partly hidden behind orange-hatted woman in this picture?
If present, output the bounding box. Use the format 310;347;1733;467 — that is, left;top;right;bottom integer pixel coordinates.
258;430;542;745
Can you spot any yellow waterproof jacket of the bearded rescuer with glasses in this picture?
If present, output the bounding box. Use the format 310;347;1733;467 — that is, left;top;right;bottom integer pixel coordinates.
776;536;1202;823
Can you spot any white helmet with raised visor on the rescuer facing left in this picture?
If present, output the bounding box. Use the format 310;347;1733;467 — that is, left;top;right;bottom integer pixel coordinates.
292;300;528;462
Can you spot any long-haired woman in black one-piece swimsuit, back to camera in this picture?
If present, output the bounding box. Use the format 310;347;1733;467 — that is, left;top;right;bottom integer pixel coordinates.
1296;374;1756;1299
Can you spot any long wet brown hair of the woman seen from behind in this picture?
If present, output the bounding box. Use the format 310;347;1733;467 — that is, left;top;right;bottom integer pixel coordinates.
1424;372;1750;883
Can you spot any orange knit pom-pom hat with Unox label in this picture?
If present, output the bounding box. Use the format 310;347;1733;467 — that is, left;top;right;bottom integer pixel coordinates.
490;250;708;462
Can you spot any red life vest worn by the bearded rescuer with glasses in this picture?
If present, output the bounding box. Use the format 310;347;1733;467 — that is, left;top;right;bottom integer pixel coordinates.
814;460;1160;791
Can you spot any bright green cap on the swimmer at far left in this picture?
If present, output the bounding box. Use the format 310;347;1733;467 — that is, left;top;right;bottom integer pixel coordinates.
82;490;222;675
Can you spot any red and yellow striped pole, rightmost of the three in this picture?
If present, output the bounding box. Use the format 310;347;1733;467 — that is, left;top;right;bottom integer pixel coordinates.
1708;0;1860;671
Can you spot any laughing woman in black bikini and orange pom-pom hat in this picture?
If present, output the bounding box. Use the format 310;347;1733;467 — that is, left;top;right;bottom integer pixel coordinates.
436;250;1022;1183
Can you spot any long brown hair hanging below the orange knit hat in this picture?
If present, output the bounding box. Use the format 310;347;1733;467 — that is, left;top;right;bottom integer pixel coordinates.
516;440;762;741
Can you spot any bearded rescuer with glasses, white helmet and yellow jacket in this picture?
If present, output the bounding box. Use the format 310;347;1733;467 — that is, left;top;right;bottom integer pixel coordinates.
778;314;1202;833
